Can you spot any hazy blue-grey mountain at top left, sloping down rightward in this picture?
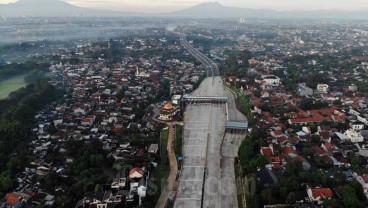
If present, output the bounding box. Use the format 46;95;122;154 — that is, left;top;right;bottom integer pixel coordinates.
0;0;122;16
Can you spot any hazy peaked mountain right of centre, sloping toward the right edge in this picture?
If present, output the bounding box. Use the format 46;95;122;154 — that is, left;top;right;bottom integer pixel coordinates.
169;2;368;19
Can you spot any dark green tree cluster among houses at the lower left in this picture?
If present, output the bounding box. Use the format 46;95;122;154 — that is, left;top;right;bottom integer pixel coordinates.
42;139;112;207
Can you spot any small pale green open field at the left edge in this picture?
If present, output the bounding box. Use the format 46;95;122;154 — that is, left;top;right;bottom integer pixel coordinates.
0;74;27;99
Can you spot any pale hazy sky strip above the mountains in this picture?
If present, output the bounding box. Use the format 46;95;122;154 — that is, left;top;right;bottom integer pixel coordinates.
0;0;368;12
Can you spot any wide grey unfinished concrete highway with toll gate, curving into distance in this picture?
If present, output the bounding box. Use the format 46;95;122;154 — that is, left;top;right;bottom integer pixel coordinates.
174;34;246;208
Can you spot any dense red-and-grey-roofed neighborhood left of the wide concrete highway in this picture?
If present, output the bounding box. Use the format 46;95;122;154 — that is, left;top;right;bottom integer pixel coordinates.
0;30;204;208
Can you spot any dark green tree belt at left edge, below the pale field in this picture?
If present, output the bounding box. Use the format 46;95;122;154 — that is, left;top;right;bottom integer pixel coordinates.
0;79;63;195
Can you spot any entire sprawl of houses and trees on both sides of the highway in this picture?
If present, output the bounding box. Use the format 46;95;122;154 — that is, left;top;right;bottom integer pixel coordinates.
0;15;368;208
